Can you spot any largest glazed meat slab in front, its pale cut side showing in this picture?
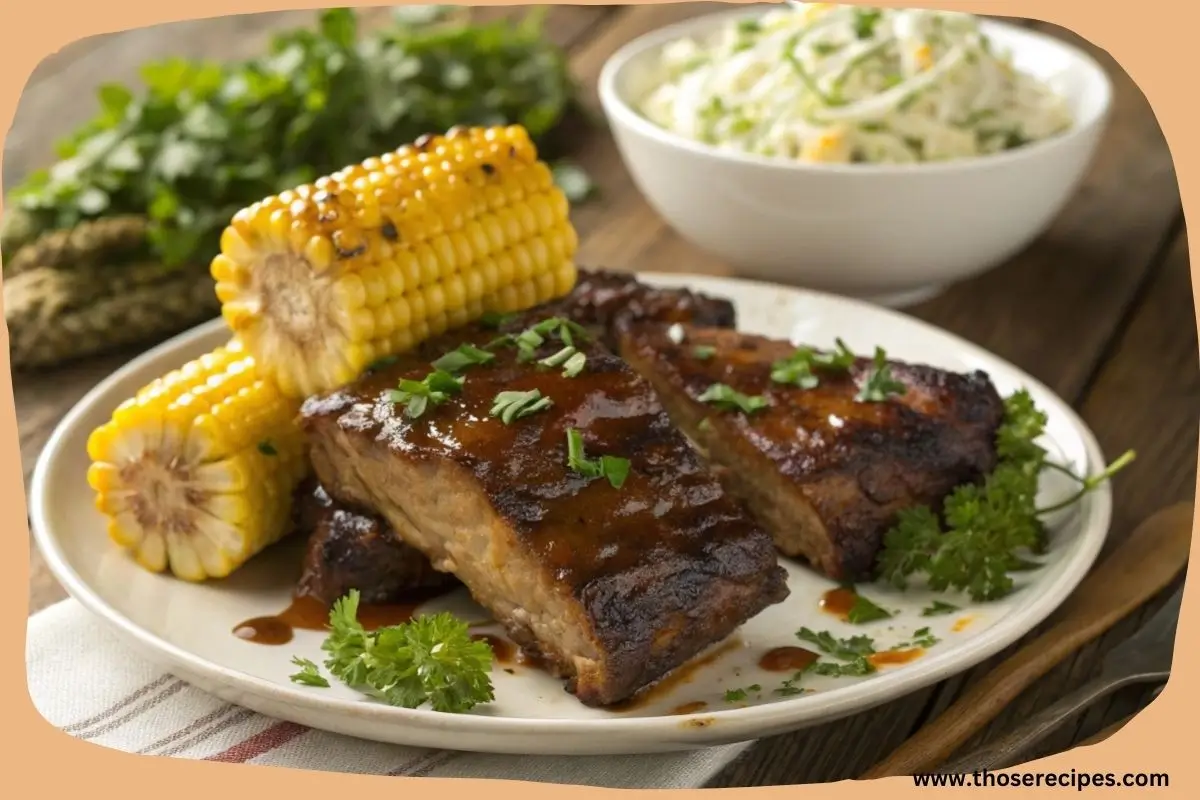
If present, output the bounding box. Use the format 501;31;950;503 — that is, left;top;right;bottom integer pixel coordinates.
301;312;787;705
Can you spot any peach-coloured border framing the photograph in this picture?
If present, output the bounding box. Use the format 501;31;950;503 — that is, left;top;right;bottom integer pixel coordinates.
0;0;1200;800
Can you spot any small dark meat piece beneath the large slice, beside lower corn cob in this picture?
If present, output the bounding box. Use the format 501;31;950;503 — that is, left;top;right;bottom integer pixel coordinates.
295;481;458;606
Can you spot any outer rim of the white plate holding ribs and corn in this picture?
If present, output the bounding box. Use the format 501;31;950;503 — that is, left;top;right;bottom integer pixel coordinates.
26;271;1112;753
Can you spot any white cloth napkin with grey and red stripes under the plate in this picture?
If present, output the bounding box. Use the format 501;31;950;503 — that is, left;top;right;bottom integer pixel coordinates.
25;600;749;789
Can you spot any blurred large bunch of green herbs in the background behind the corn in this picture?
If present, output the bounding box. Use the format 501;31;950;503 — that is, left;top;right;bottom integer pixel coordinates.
5;6;576;266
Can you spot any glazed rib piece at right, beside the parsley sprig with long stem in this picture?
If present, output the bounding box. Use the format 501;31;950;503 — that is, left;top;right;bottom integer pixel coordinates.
620;324;1003;579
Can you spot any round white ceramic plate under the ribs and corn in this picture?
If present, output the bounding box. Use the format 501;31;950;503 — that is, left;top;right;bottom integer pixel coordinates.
29;275;1111;754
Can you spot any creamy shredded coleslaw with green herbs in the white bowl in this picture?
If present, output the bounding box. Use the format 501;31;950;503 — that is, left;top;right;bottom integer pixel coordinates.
638;2;1073;163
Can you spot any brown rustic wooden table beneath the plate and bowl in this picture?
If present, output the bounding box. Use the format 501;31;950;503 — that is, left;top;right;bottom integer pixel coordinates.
11;4;1200;786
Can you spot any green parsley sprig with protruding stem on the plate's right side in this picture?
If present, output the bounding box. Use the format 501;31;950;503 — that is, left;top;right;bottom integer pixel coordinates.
878;390;1134;601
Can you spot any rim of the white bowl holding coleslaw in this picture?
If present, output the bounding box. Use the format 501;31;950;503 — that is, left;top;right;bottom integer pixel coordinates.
596;2;1114;176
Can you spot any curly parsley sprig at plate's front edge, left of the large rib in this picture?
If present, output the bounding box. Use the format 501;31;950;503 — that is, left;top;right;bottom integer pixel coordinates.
316;589;494;714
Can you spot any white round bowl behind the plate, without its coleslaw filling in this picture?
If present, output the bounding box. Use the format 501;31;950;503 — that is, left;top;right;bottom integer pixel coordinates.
599;6;1112;305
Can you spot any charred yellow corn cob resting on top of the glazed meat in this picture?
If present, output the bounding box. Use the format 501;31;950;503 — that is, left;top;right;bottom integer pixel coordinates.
212;126;578;397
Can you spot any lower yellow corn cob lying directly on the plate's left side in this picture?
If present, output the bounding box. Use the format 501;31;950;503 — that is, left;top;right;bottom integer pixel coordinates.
88;339;308;581
